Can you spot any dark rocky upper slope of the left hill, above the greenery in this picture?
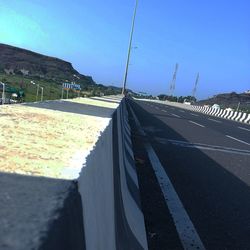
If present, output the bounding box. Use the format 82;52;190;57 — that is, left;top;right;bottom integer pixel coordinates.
0;43;95;85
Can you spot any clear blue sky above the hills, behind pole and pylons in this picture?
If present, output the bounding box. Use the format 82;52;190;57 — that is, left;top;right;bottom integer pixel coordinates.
0;0;250;99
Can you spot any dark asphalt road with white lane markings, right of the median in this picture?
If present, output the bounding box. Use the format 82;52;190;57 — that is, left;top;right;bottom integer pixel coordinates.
129;100;250;249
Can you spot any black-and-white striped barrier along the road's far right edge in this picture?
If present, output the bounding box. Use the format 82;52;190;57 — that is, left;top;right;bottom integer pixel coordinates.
191;105;250;124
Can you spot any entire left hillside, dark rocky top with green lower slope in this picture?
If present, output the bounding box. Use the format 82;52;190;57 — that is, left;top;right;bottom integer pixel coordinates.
0;43;121;102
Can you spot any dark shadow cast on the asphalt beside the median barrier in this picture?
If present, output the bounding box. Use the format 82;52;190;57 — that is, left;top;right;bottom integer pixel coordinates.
129;101;250;249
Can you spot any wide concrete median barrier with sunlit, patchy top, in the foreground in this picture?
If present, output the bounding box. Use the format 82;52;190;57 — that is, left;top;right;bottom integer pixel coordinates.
0;96;148;250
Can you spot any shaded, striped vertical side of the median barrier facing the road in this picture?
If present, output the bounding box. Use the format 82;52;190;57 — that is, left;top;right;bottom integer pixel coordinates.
78;99;147;250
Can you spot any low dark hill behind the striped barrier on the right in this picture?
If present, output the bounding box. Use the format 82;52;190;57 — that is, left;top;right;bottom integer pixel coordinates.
196;92;250;110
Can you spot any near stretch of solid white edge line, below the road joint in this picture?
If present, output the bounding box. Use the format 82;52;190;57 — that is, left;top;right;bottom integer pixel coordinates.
145;143;205;249
